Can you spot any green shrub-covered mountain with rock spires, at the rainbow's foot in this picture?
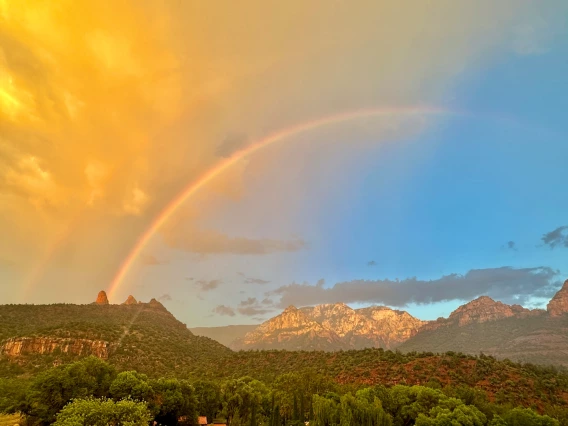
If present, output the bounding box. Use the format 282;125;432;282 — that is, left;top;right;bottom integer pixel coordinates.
0;293;231;375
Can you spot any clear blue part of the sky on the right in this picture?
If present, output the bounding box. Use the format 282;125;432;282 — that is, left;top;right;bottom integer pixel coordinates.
154;22;568;324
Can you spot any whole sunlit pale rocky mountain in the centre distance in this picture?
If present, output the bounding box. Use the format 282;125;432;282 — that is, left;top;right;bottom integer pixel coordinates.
230;303;423;351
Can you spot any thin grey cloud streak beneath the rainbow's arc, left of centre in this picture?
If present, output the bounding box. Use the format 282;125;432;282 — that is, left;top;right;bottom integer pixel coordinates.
163;229;308;255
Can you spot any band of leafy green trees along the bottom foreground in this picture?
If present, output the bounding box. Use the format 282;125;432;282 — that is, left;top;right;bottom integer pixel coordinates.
0;356;568;426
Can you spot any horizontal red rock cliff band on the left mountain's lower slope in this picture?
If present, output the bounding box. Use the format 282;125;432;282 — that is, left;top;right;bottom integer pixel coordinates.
0;337;110;359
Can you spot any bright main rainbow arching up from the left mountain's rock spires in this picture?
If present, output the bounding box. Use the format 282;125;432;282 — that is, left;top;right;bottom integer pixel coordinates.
107;106;459;298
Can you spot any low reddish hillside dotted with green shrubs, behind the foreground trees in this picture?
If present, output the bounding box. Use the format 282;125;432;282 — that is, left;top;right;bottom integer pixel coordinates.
187;348;568;407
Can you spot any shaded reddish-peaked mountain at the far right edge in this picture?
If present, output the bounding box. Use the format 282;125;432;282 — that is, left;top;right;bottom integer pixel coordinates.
399;281;568;366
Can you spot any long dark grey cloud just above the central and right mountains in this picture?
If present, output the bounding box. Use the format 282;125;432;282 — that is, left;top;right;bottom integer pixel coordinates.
272;267;559;307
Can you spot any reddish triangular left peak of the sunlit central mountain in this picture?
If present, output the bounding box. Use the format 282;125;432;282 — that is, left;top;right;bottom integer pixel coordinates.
232;306;348;351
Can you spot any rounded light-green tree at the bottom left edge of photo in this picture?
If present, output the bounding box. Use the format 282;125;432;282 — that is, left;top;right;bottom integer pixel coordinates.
53;398;152;426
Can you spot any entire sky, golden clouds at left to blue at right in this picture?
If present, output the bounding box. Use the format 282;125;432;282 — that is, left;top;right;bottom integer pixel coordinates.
0;0;568;326
